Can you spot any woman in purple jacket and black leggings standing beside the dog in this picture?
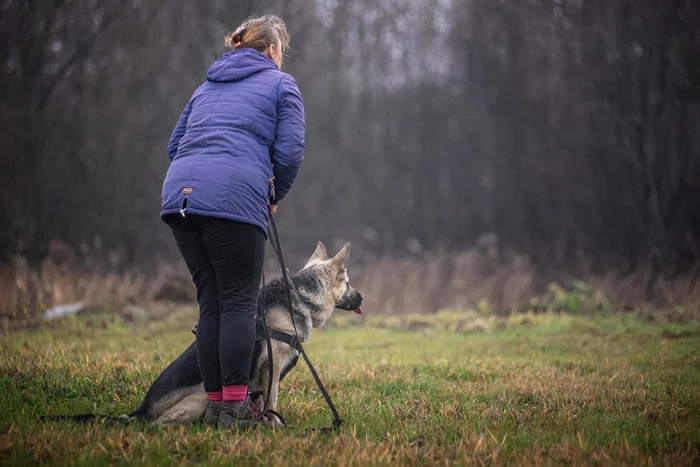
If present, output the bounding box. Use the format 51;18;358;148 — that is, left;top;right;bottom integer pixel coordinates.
161;16;305;427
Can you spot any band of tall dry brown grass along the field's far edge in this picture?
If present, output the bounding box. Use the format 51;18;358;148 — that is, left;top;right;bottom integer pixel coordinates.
0;241;700;317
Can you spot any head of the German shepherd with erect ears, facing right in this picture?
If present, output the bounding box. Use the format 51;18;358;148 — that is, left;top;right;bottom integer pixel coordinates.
302;242;362;314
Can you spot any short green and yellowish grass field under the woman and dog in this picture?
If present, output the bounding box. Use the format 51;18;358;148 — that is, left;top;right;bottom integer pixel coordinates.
0;309;700;465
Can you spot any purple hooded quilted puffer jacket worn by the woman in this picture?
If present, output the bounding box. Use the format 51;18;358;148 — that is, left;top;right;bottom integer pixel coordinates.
161;48;305;232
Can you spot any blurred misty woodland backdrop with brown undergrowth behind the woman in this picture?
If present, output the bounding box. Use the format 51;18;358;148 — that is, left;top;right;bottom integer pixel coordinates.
0;0;700;318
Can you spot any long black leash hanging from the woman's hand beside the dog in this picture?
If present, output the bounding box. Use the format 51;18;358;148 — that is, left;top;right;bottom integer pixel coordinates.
261;213;343;432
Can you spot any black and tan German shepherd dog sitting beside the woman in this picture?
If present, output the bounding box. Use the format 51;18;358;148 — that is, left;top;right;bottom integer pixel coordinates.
54;242;362;426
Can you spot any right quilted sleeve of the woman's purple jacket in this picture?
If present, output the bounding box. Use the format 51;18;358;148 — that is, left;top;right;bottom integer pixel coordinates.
272;75;306;201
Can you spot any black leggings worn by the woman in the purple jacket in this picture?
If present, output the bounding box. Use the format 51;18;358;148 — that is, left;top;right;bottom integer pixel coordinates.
165;214;266;392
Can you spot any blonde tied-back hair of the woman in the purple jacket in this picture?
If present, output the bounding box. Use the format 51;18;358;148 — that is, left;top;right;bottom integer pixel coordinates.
225;15;289;56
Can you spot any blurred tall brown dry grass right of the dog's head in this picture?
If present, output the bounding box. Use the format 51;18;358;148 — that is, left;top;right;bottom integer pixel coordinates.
351;249;700;318
